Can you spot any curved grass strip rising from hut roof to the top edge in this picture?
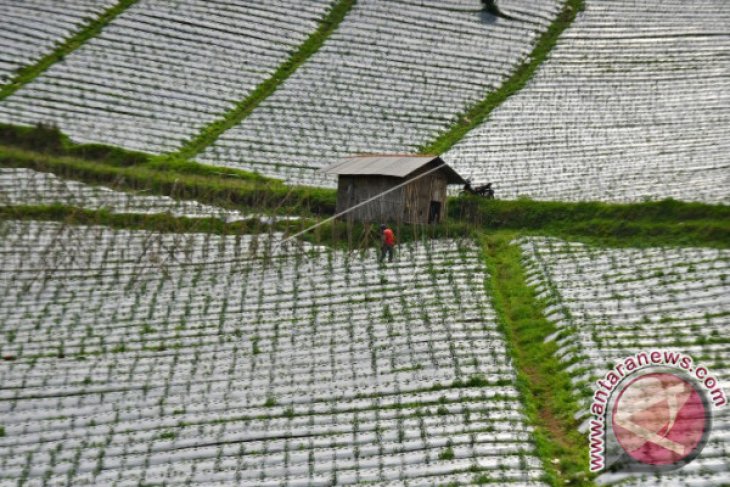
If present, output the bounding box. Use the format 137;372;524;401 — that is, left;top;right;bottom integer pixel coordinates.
419;0;585;154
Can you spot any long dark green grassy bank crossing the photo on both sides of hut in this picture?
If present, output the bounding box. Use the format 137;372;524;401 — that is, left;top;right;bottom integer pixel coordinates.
0;125;730;248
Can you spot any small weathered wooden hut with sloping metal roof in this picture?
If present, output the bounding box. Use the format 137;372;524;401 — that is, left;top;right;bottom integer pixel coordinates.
322;155;465;223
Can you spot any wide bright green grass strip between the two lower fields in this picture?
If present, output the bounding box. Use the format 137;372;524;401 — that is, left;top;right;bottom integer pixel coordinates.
481;232;594;486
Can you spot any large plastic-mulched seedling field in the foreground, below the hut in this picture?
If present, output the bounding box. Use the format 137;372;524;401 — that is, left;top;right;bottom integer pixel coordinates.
0;221;542;486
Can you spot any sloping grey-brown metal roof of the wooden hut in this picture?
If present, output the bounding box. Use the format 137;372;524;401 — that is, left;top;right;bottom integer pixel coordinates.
322;155;465;184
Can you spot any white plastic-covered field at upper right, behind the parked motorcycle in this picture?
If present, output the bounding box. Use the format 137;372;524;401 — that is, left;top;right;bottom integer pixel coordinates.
445;0;730;202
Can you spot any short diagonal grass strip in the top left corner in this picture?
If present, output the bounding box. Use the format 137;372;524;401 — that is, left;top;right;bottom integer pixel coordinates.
0;0;137;100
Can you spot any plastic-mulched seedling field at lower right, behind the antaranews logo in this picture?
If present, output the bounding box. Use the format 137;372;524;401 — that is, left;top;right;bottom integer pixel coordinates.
519;237;730;486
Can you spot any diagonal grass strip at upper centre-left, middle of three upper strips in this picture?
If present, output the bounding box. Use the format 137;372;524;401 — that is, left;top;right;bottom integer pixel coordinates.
172;0;356;159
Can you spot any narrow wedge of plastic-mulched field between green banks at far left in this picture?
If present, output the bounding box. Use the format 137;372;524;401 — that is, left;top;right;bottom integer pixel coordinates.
0;167;250;221
